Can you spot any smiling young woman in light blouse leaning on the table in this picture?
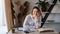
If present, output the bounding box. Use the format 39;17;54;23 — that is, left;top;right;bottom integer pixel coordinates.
23;6;41;31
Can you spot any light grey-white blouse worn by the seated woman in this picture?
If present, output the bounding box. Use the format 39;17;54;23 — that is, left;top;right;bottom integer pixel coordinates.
23;14;41;31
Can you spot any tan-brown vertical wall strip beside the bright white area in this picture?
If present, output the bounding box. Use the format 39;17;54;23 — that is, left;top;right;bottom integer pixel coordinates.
5;0;13;30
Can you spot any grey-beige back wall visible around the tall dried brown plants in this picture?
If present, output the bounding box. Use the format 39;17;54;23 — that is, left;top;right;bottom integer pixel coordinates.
12;0;38;13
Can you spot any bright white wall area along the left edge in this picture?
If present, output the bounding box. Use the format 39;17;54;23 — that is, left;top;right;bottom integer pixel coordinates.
0;0;8;34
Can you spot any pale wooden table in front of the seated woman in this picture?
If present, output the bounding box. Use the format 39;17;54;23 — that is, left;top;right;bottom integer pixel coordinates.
7;29;59;34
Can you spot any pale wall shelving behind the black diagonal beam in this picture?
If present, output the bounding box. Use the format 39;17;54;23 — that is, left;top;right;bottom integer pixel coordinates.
42;0;60;32
